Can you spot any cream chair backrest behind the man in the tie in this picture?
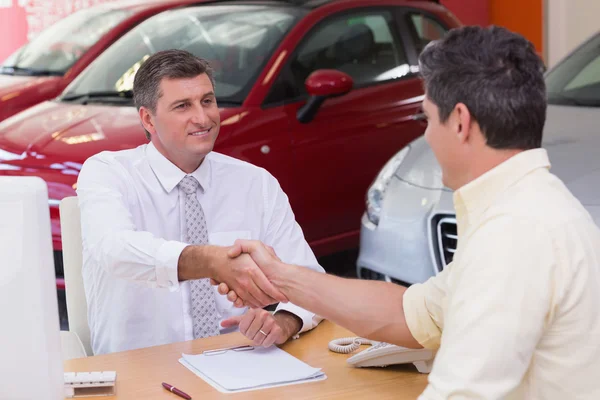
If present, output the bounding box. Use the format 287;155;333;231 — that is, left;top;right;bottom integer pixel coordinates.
59;196;94;355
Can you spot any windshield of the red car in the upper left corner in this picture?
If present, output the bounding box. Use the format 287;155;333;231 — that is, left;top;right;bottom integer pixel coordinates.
0;6;131;75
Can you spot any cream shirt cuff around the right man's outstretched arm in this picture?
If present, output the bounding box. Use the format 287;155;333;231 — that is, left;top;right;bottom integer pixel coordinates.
402;284;442;350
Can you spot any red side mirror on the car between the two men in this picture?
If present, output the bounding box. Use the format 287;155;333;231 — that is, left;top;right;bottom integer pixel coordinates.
296;69;354;124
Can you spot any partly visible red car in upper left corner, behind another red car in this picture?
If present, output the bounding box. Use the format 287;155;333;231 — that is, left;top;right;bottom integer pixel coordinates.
0;0;204;121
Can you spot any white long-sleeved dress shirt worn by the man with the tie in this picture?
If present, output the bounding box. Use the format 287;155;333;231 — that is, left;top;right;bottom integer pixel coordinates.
77;144;324;354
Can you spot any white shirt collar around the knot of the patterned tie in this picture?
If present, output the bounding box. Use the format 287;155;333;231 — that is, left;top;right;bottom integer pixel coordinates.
146;143;211;193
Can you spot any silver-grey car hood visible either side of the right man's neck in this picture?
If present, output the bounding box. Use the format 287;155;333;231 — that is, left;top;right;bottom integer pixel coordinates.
395;105;600;205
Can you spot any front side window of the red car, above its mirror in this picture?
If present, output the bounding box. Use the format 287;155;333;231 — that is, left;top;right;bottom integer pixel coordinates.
266;11;408;103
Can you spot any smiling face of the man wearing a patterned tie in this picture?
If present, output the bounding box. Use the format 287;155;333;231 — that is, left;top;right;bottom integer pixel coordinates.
145;74;221;173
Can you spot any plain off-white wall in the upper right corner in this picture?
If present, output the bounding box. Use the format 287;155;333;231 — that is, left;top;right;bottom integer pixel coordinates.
544;0;600;67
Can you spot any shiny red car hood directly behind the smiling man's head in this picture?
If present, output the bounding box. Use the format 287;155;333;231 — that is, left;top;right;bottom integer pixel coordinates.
0;101;246;167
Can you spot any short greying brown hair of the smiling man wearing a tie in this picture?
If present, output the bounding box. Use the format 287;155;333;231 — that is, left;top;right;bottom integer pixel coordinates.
133;49;215;139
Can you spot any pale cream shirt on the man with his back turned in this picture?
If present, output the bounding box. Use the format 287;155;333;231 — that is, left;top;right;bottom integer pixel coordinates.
404;149;600;400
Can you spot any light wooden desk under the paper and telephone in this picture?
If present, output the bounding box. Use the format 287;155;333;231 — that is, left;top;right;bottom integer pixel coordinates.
65;321;427;400
